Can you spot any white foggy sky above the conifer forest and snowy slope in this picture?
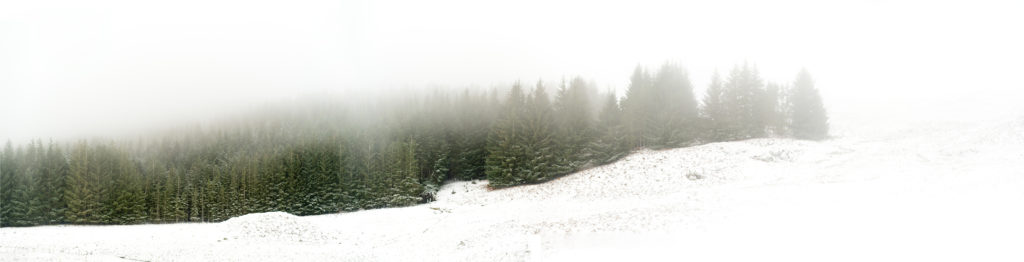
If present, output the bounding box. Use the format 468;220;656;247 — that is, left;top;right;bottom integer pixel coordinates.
0;0;1024;143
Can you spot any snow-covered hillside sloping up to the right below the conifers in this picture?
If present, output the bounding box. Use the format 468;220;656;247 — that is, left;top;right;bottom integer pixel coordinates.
0;103;1024;261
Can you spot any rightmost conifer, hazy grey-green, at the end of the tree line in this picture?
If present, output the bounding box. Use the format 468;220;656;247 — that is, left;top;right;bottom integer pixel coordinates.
790;70;828;140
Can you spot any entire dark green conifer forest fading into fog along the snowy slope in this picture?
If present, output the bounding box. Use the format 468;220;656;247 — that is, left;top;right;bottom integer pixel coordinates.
0;63;828;226
